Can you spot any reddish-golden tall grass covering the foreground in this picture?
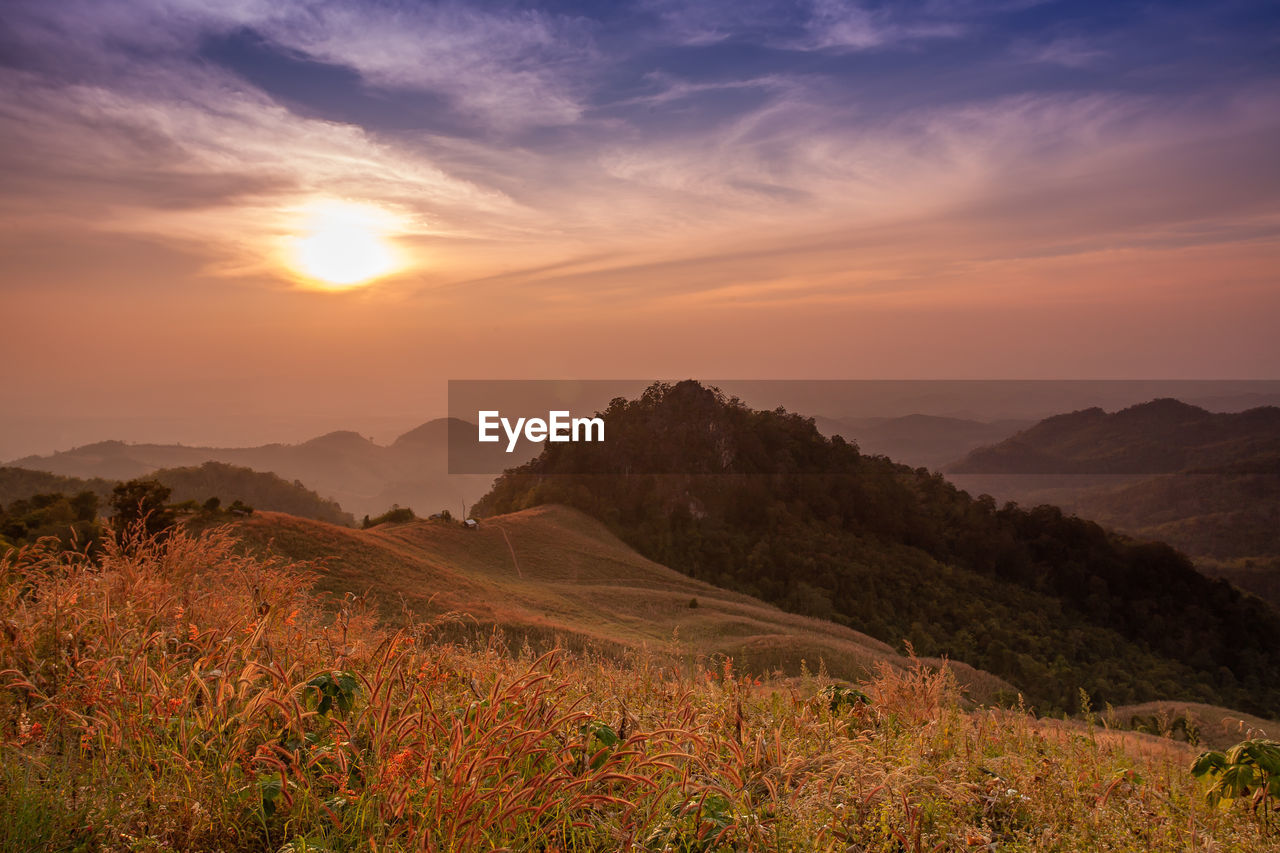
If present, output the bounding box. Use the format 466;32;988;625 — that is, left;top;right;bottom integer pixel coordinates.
0;530;1275;853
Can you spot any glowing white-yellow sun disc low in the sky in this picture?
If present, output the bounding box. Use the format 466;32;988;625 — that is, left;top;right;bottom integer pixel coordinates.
287;200;404;289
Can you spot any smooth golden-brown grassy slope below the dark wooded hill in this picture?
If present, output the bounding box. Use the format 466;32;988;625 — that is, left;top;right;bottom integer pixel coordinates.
225;506;1010;701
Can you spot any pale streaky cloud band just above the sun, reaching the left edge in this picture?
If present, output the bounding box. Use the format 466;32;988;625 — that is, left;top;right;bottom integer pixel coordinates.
0;59;527;280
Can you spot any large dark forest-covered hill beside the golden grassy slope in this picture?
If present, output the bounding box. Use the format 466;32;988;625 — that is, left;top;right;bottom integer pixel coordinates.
476;382;1280;715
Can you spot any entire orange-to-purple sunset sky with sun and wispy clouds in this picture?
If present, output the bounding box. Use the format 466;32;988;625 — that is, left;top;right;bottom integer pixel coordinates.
0;0;1280;450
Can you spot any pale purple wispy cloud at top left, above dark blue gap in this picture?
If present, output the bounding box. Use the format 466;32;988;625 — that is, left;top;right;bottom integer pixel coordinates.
5;0;599;129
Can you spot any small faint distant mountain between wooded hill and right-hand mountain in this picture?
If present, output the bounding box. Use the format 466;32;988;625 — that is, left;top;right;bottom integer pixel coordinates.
814;415;1033;470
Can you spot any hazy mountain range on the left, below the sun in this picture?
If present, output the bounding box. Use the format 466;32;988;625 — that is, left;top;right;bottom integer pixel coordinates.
10;418;519;515
